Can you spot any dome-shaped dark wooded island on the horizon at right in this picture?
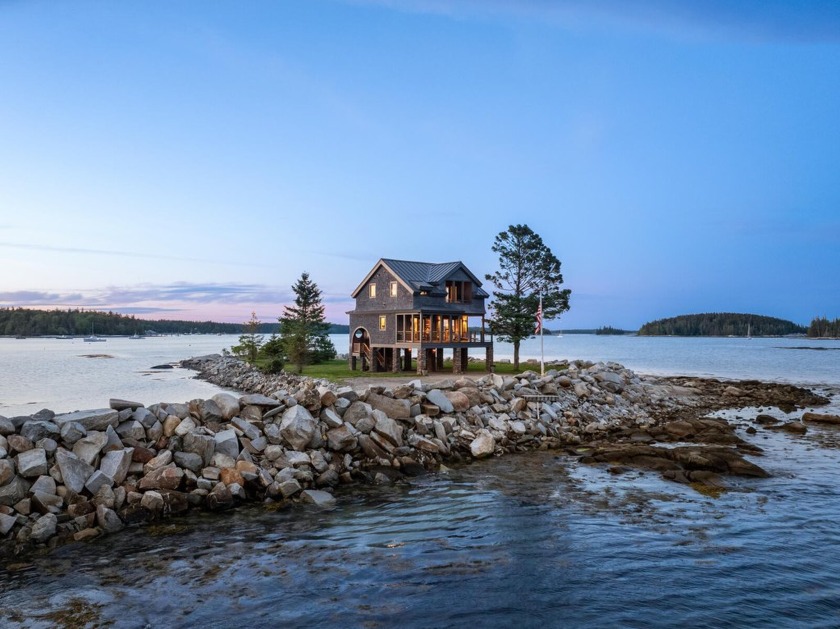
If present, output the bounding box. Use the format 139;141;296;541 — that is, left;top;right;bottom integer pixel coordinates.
639;312;806;336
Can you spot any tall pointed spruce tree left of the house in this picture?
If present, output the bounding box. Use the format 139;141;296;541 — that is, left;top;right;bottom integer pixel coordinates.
279;271;336;373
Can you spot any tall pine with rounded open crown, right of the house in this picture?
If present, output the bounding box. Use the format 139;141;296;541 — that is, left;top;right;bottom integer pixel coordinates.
485;225;571;369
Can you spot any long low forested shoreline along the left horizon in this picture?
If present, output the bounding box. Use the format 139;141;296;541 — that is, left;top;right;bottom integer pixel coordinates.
0;308;349;336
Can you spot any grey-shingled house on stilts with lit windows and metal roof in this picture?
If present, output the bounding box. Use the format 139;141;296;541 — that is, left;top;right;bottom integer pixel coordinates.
347;258;493;374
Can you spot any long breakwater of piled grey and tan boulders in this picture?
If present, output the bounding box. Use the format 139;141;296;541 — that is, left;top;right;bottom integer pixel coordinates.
0;355;828;555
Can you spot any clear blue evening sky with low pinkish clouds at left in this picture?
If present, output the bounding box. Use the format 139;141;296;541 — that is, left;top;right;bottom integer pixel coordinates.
0;0;840;329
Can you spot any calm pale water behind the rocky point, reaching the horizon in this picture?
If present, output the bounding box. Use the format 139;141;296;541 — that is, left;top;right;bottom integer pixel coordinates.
0;334;840;416
